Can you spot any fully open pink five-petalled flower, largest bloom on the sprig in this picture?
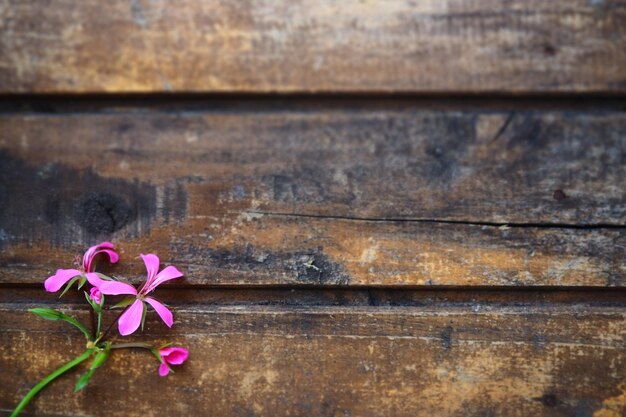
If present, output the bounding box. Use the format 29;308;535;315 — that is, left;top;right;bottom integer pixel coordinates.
98;253;183;336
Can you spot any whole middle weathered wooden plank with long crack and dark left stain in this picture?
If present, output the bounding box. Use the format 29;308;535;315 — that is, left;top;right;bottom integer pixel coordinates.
0;111;626;286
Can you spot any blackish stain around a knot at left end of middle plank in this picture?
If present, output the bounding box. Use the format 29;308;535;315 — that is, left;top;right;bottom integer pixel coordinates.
0;150;156;244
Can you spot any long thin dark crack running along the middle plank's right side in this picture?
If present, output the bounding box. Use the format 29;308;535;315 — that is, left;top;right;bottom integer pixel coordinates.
243;210;626;230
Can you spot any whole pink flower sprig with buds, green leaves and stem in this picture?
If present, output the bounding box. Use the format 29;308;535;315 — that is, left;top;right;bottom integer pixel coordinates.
11;242;189;417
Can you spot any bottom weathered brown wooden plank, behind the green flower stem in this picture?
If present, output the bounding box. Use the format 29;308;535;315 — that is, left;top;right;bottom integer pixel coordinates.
0;304;626;417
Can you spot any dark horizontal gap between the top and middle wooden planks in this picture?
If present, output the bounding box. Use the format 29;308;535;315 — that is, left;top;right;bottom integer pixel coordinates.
0;92;626;116
